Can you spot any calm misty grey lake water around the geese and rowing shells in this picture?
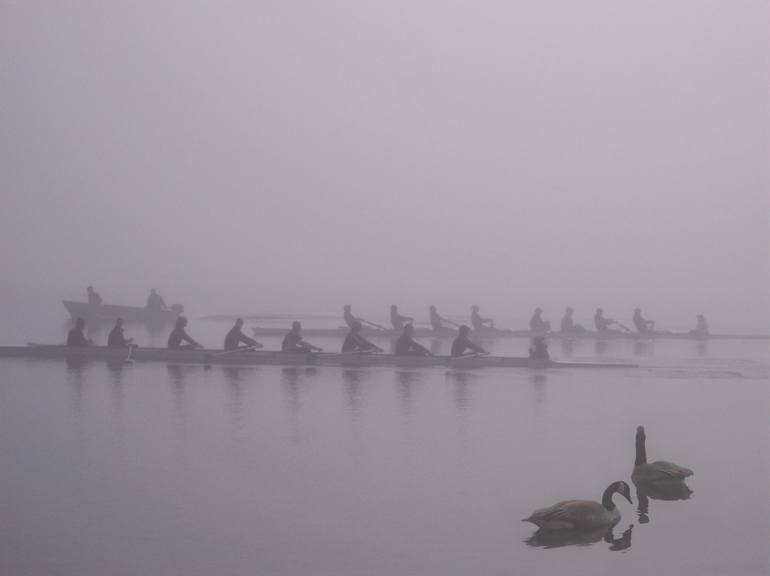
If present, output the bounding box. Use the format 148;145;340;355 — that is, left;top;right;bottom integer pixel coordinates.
0;325;770;576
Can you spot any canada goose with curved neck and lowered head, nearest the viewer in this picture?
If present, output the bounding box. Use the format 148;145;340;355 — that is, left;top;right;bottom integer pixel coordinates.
522;481;631;530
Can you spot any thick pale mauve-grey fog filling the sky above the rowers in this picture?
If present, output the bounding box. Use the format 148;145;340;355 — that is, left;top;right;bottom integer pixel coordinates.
0;0;770;331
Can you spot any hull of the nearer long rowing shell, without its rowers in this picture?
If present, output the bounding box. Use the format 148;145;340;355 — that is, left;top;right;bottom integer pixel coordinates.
0;344;638;369
